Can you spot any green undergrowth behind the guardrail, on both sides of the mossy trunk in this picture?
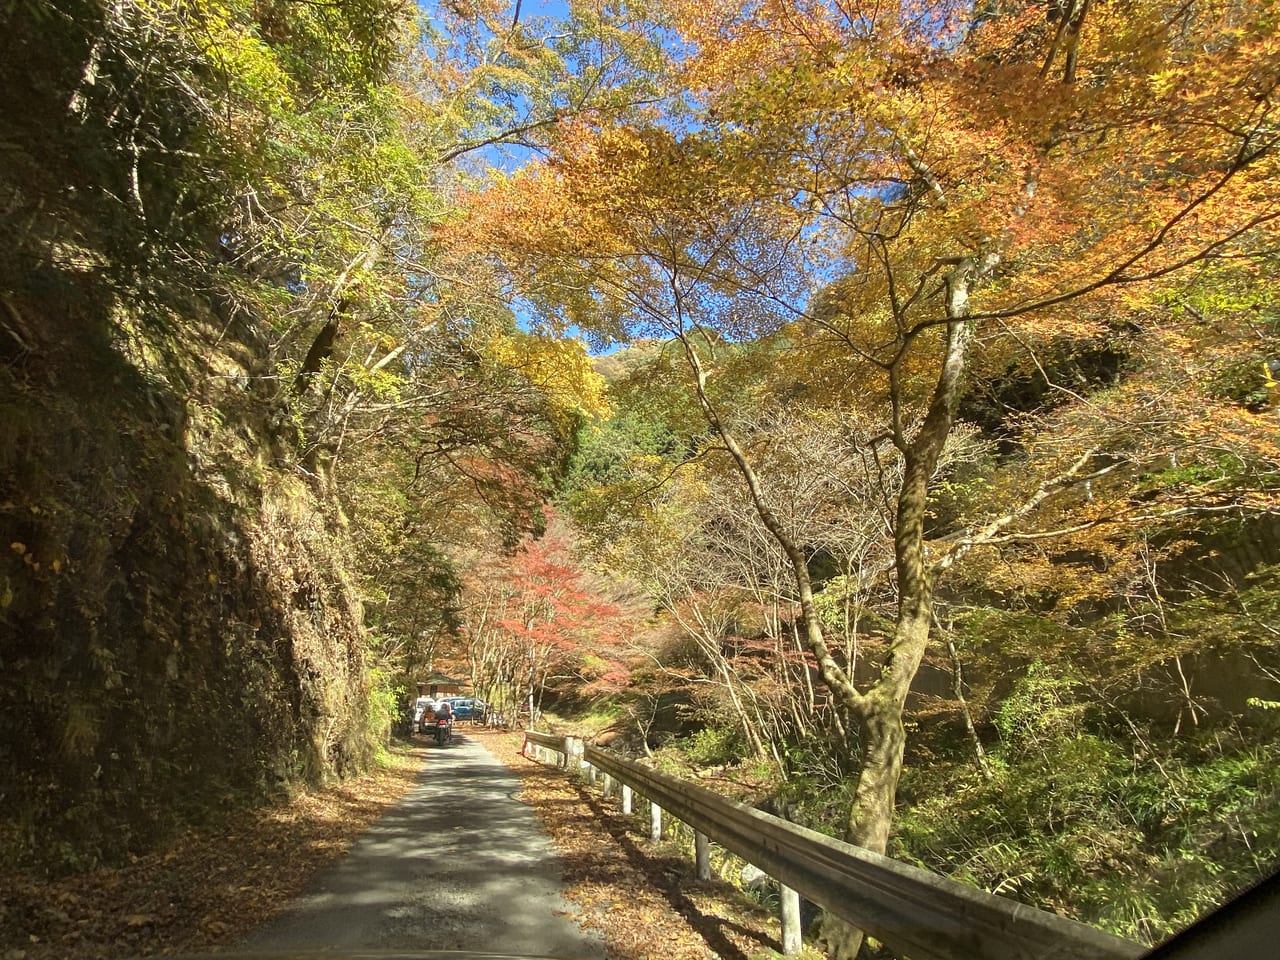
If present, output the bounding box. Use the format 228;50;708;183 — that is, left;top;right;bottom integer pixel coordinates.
560;547;1280;943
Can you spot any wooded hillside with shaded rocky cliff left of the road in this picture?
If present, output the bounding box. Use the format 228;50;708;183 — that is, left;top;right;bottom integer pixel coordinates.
0;0;619;870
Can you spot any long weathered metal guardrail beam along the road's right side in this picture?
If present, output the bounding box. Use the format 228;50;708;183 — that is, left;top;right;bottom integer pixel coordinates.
525;733;1147;960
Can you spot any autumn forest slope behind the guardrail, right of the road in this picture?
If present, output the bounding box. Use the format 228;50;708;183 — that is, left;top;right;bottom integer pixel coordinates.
458;1;1280;955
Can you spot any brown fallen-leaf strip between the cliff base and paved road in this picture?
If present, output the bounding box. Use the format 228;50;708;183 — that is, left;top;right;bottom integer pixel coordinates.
0;748;425;960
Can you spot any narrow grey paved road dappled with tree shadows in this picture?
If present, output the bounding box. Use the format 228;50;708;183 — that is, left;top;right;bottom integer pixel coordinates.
244;723;604;960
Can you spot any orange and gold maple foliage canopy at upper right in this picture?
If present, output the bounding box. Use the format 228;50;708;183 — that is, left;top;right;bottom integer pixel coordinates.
454;3;1280;345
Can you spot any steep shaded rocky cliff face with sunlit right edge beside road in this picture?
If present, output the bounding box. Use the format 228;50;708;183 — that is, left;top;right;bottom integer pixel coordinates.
0;285;375;868
